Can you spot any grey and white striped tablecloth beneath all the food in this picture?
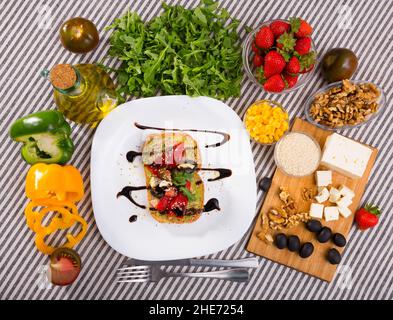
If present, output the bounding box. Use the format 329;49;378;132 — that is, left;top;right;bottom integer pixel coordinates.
0;0;393;299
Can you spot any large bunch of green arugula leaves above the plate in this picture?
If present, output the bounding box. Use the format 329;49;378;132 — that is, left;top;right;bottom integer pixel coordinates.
106;0;242;99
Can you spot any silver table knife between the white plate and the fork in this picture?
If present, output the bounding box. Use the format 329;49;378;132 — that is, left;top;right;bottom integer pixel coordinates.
124;257;259;268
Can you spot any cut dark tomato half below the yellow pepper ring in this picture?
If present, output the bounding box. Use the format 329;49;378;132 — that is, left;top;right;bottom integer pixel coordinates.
50;248;82;286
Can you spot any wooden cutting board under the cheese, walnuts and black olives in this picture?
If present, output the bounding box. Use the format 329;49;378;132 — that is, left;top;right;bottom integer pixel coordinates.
247;118;378;282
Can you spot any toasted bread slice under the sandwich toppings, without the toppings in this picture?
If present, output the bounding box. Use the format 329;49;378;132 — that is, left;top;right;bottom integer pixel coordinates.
142;132;204;223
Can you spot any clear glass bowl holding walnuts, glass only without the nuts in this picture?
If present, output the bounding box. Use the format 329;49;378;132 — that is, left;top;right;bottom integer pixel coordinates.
304;80;386;131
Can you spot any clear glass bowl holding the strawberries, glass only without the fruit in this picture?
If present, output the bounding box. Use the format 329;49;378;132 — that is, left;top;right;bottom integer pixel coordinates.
242;19;318;94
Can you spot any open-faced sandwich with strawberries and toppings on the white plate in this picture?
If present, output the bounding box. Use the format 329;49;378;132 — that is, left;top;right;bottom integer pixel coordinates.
142;132;204;223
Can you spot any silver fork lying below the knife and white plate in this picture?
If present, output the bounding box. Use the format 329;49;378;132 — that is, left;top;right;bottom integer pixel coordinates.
117;266;249;282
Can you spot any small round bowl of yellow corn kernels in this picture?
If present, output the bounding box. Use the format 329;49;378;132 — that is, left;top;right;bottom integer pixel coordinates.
243;100;289;145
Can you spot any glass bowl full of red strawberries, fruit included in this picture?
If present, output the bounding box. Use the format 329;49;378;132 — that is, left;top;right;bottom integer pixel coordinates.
243;17;317;94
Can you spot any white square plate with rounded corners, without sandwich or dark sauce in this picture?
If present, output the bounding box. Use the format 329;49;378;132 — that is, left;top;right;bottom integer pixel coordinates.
91;96;256;260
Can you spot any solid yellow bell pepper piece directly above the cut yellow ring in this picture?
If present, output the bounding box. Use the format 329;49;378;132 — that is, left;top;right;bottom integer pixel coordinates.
25;163;84;205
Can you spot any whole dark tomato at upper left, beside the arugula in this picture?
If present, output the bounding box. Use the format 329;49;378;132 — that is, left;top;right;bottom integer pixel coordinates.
60;17;100;53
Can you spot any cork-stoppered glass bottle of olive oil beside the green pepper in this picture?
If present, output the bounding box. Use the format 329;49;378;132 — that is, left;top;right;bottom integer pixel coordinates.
43;64;118;127
